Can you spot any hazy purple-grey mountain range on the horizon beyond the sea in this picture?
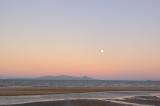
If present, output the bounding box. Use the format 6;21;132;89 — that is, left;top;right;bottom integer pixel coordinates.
36;75;95;80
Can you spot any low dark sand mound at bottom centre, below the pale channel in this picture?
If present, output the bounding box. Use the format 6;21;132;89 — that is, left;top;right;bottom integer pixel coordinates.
0;100;126;106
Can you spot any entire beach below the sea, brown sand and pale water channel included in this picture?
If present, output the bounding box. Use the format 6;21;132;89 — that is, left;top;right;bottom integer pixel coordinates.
0;87;160;106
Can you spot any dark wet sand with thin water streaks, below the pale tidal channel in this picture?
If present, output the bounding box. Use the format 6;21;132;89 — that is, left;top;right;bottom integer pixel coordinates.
0;96;160;106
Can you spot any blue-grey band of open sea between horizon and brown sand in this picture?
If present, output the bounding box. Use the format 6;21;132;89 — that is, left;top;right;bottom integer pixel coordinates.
0;79;160;88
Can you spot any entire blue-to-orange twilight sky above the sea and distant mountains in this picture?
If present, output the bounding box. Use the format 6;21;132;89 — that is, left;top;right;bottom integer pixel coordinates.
0;0;160;80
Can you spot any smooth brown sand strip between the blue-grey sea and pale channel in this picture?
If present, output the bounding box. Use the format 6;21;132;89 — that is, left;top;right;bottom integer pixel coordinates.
0;87;160;96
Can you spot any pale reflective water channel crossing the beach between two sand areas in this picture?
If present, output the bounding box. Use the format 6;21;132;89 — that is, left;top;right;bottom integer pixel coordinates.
0;91;160;105
